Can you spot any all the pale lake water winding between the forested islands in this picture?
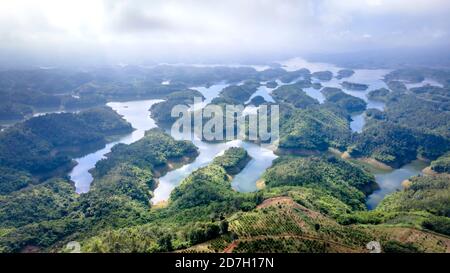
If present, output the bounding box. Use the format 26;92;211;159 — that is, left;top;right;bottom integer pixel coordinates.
69;60;425;208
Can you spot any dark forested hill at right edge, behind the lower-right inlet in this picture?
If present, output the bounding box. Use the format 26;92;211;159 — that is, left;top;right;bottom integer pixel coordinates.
349;84;450;166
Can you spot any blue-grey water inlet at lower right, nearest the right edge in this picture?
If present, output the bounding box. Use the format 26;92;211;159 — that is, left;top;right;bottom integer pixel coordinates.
366;160;427;209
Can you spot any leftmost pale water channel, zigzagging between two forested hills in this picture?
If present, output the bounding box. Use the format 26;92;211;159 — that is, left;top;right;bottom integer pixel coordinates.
69;100;161;193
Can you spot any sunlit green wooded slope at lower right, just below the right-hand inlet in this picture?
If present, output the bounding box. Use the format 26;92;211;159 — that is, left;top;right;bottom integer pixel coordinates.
338;174;450;237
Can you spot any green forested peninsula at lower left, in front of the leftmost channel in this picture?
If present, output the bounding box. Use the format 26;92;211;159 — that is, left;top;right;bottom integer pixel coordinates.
0;130;200;252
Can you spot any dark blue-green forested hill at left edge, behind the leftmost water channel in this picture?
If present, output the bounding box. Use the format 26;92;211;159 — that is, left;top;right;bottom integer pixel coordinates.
0;107;132;189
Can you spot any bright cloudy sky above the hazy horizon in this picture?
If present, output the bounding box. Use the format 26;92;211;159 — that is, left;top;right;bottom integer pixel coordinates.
0;0;450;65
